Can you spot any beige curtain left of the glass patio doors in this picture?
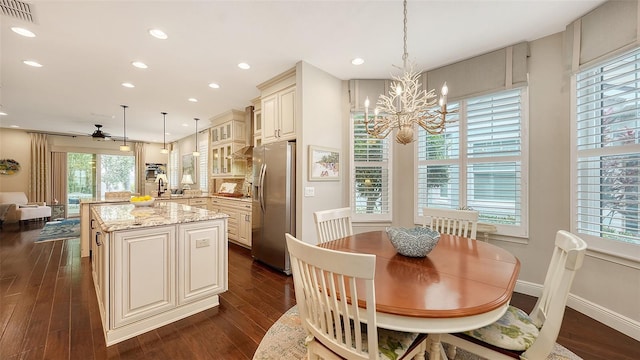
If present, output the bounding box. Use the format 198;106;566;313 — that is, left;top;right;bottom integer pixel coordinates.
29;133;49;202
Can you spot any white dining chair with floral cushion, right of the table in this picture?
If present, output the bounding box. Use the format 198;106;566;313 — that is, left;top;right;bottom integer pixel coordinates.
440;230;587;360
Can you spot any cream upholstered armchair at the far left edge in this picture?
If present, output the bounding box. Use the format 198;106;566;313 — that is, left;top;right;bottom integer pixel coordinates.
0;192;51;224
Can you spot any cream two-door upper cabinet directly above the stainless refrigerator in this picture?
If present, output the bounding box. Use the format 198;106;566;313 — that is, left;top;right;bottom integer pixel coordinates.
258;68;296;144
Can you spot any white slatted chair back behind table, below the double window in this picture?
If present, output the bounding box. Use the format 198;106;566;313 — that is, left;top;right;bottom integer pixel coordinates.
422;208;479;239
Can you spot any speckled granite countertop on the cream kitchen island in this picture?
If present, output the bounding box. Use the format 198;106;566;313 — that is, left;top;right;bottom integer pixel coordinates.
92;201;229;232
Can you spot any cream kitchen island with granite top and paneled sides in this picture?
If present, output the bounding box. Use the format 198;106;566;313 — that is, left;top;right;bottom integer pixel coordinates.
90;202;228;346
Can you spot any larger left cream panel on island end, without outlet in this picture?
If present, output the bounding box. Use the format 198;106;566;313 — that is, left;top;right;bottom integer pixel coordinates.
112;226;176;328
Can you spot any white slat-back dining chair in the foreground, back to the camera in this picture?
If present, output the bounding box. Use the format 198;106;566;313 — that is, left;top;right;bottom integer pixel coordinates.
285;234;426;360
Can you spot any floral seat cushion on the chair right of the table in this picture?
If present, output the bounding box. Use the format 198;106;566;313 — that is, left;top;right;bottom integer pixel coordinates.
464;306;540;351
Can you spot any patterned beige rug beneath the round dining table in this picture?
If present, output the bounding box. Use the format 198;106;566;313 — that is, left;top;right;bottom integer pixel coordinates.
253;306;581;360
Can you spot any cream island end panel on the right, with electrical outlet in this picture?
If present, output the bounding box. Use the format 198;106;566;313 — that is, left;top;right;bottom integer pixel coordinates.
178;221;227;305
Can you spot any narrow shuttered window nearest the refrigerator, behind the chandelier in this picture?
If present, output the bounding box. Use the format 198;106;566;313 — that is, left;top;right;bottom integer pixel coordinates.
351;112;393;221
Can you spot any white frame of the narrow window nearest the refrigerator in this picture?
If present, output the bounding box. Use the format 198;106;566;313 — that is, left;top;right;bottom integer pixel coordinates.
349;111;394;222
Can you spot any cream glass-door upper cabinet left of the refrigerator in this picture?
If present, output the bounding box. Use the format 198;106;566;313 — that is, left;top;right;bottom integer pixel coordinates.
209;110;250;177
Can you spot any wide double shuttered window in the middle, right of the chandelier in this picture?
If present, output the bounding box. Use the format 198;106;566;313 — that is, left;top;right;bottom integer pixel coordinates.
415;89;527;236
